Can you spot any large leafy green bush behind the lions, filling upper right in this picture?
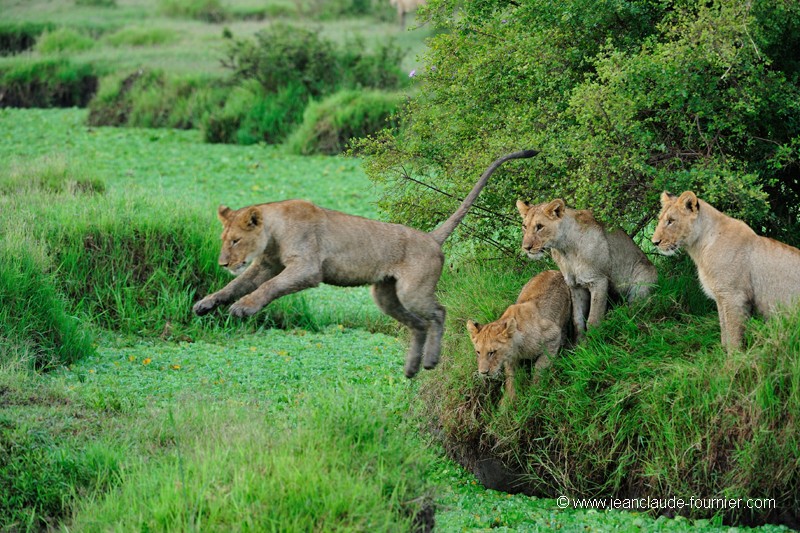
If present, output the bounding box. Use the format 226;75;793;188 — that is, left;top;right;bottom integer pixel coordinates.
364;0;800;248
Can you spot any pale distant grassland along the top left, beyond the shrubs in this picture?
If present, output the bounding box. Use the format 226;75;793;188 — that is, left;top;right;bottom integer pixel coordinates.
0;0;432;77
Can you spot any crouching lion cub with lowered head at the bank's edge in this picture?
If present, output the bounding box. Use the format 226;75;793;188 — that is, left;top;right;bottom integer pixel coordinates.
467;270;571;400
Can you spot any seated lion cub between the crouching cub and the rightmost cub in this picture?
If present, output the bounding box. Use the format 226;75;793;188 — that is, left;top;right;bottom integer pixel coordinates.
517;199;658;337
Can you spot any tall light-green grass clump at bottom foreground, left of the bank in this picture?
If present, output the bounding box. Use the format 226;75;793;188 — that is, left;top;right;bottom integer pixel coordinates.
72;389;432;531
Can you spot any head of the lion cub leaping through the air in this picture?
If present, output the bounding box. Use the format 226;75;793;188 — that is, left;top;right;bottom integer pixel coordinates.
217;205;267;276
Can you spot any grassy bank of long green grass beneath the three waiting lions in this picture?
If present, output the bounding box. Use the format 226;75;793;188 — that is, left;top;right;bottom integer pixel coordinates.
421;256;800;523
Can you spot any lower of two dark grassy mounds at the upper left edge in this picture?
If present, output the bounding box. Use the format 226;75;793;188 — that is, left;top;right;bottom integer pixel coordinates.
0;59;97;107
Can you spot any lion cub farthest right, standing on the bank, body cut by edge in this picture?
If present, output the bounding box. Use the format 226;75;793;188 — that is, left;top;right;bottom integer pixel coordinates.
652;191;800;352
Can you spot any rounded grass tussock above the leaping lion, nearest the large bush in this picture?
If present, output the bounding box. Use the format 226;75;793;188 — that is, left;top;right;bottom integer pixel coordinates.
286;90;405;155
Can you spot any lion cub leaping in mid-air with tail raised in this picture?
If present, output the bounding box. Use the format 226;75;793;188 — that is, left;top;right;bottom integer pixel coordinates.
193;150;538;378
